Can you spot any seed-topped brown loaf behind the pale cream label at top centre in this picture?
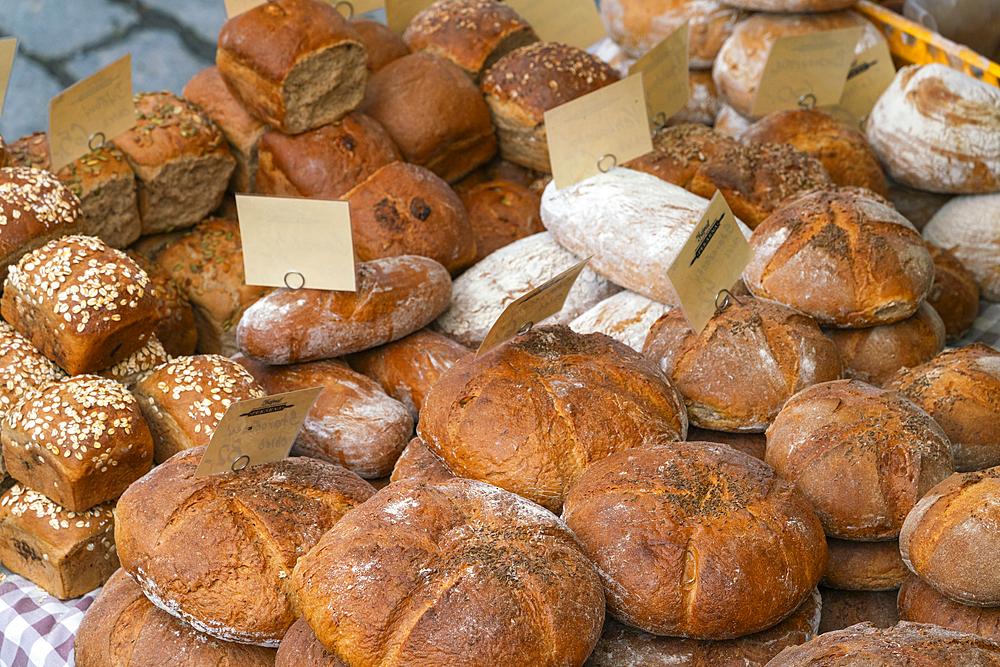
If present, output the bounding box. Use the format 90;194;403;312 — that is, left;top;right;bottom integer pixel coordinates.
479;42;621;172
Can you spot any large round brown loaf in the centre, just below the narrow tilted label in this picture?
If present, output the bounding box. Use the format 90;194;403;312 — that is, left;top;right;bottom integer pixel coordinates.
417;325;687;511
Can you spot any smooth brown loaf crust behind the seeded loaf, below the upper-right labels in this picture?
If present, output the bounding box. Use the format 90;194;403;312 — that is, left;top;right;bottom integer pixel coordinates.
740;108;889;197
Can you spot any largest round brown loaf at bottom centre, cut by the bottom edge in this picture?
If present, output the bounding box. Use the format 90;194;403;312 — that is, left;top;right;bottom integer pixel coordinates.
292;478;604;667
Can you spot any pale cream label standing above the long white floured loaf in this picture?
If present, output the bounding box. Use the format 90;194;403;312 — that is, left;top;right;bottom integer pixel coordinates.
545;74;653;190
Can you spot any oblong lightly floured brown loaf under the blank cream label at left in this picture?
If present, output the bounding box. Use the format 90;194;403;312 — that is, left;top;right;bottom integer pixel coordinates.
236;255;451;364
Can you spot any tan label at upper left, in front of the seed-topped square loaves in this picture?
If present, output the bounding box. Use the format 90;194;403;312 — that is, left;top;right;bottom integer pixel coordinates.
49;54;135;172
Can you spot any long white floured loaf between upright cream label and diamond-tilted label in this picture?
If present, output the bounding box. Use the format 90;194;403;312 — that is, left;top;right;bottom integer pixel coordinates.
541;169;750;306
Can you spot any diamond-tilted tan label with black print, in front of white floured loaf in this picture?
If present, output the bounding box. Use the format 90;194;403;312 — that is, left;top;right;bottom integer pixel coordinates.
667;190;753;335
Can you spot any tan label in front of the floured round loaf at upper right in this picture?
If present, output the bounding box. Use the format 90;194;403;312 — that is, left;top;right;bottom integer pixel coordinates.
751;26;864;118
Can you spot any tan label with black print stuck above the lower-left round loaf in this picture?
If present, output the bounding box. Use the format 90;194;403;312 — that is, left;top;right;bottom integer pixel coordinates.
194;387;324;478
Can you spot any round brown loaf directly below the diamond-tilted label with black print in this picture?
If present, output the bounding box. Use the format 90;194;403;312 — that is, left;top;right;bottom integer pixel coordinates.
642;297;841;432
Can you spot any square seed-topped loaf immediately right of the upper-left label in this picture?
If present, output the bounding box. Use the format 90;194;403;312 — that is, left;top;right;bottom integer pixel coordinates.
114;91;236;234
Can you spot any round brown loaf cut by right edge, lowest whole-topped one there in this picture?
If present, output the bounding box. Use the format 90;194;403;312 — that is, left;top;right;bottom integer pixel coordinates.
899;468;1000;607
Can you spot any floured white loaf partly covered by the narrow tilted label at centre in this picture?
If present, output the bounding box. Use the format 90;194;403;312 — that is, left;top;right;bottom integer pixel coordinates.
434;232;620;348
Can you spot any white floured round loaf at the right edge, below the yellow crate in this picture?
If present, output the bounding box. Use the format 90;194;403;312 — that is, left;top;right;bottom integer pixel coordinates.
865;63;1000;194
